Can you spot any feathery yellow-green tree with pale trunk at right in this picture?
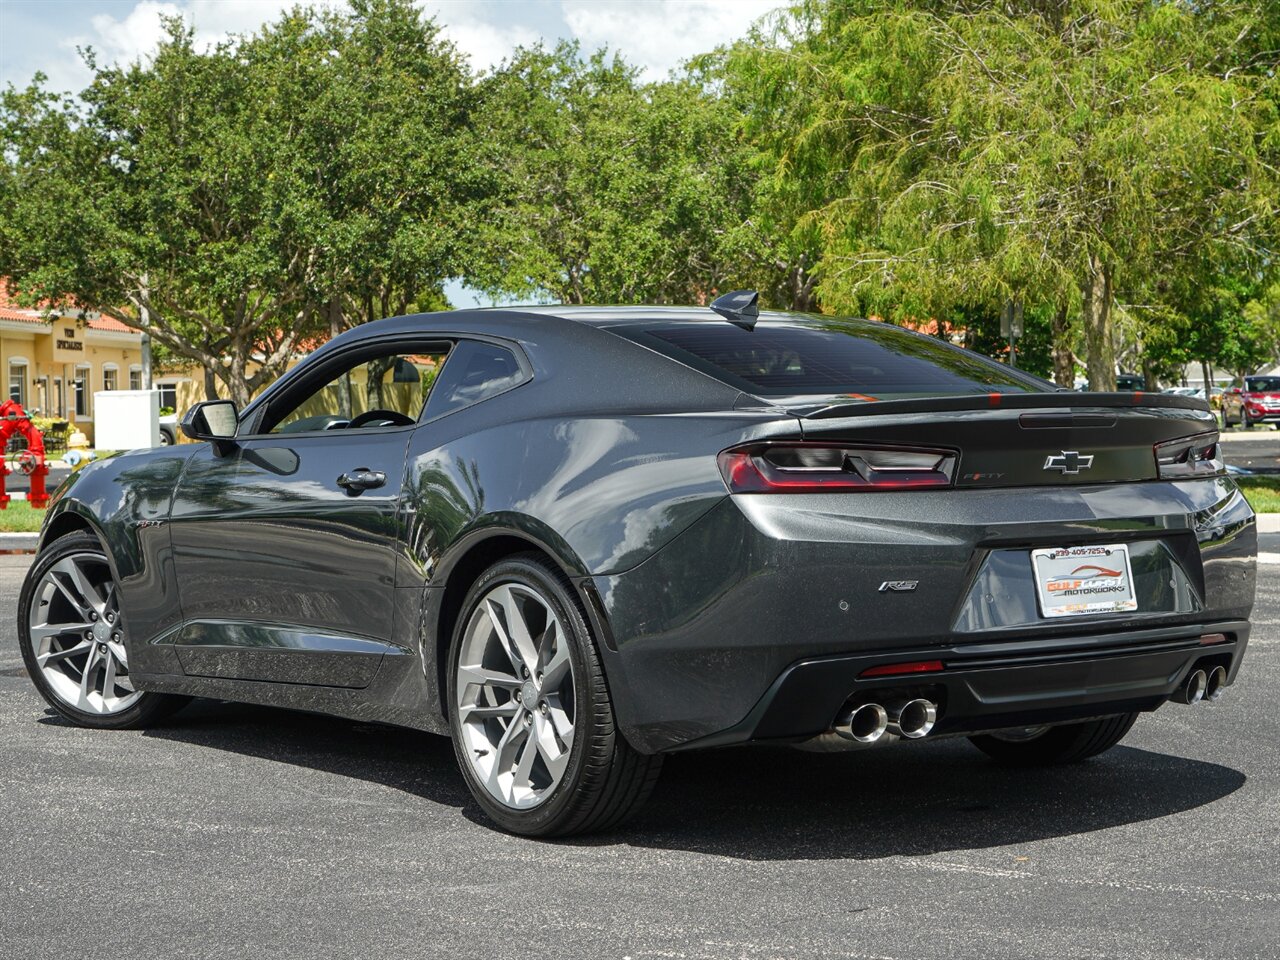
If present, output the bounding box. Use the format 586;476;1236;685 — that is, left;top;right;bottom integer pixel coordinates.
730;0;1276;389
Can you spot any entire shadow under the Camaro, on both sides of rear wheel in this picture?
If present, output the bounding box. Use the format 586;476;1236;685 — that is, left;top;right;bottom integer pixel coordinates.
104;701;1245;860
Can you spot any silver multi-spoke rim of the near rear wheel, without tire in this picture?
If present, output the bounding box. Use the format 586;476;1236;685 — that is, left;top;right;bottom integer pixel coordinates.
453;582;575;810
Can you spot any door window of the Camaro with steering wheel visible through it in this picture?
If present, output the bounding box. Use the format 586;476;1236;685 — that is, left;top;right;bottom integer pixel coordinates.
262;344;448;434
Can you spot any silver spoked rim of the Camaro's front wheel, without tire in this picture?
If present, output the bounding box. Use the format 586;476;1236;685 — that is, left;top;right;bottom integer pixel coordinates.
27;553;142;716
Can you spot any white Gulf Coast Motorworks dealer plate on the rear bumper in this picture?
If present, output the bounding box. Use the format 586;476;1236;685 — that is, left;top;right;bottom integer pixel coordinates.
1032;544;1138;617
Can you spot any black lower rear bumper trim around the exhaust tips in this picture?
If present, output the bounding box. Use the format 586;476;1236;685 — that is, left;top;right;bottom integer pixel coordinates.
680;621;1249;749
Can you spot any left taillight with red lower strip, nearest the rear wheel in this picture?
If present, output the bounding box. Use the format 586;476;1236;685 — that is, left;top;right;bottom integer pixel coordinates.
719;443;956;493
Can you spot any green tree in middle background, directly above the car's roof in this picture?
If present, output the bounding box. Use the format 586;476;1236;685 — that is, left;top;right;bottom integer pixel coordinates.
479;44;754;303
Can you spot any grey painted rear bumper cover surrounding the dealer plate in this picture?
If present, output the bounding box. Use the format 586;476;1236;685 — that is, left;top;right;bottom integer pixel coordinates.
593;477;1257;753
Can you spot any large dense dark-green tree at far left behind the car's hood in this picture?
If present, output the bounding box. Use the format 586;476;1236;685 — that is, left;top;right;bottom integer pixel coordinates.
0;0;475;403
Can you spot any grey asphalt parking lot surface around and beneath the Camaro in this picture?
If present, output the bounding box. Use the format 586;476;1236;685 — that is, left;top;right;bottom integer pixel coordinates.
0;547;1280;960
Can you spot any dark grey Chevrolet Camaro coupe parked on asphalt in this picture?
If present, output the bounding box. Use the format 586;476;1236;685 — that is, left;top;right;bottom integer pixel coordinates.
18;292;1257;836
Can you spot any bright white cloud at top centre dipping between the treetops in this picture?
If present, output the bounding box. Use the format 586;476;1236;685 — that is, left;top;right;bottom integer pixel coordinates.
561;0;781;81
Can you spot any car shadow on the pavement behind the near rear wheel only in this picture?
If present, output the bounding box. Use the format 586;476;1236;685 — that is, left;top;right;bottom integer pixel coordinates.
627;742;1245;860
